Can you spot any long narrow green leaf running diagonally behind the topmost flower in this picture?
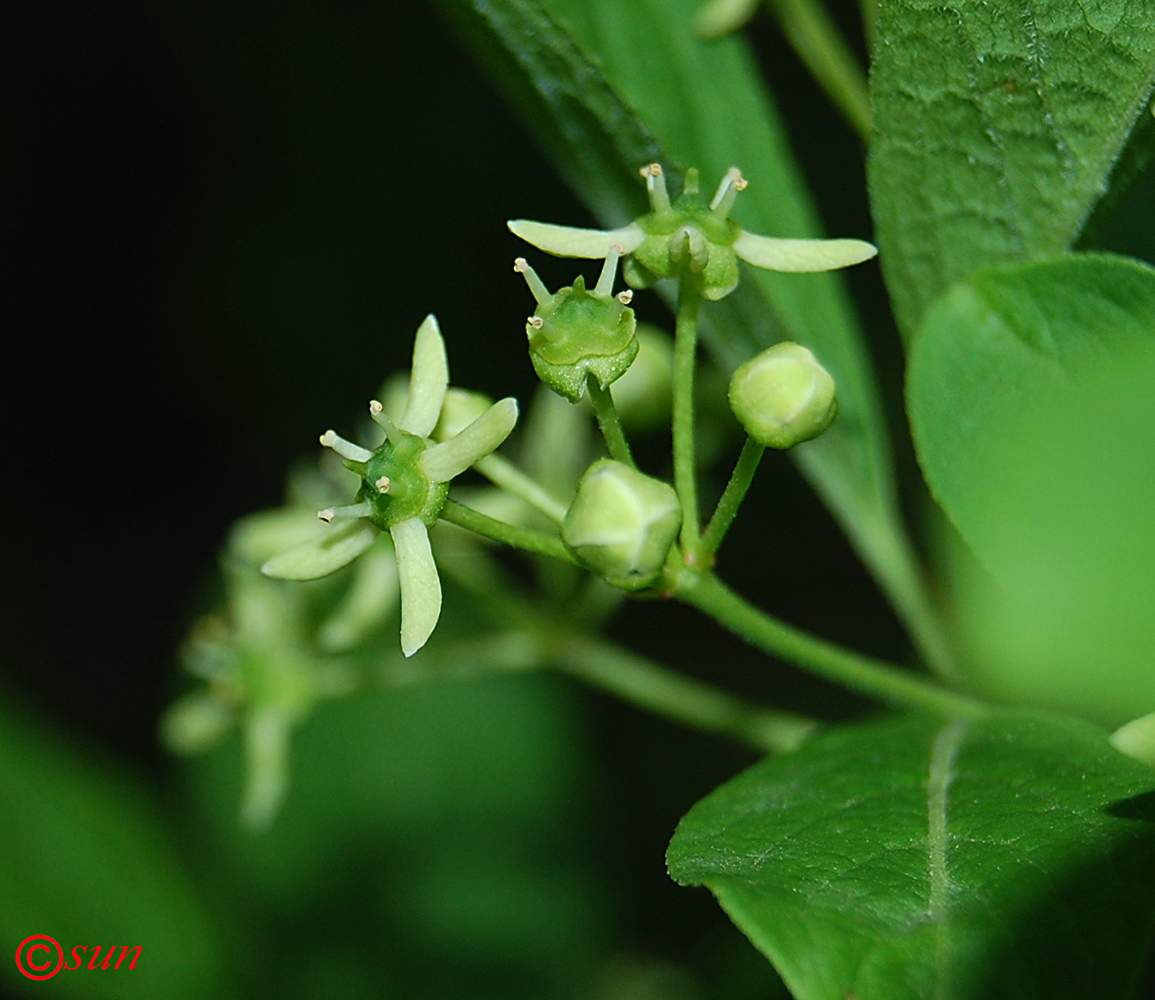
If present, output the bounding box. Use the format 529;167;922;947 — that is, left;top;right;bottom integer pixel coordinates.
442;0;948;678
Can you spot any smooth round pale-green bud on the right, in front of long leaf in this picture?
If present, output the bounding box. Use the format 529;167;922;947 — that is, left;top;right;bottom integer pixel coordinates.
730;342;839;448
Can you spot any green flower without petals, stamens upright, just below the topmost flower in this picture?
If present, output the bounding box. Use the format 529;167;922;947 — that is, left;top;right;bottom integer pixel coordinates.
514;248;638;403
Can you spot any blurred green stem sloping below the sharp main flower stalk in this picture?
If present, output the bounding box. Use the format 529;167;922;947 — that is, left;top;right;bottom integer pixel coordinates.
551;639;817;752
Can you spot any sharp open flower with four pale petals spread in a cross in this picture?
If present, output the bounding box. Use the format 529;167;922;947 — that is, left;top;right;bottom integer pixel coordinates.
261;315;517;656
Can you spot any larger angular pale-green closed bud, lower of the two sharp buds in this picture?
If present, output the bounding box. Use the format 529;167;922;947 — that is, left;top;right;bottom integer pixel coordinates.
561;458;681;590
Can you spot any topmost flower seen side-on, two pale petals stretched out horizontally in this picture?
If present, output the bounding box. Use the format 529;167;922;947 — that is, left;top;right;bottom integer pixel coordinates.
508;163;878;300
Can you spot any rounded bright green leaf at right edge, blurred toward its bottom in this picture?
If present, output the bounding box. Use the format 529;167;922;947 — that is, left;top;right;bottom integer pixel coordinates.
908;256;1155;725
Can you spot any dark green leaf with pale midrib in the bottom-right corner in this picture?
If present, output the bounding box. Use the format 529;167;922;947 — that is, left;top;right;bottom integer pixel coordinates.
669;714;1155;1000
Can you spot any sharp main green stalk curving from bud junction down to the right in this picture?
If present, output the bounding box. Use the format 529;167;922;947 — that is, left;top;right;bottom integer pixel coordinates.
673;570;988;718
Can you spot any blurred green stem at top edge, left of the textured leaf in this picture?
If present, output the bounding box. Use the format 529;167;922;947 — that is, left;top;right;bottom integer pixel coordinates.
768;0;871;142
